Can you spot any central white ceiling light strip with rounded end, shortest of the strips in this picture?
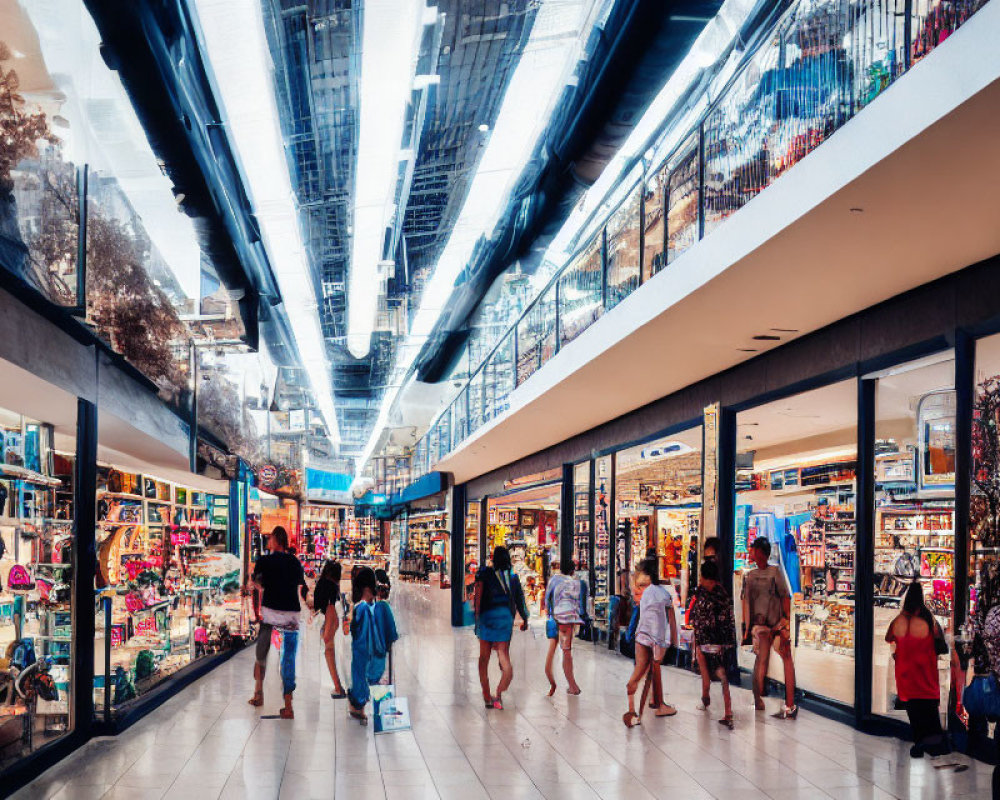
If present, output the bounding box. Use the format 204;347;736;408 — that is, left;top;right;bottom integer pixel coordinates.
347;0;426;358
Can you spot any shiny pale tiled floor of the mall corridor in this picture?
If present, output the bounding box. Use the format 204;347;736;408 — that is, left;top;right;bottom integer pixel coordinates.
5;587;991;800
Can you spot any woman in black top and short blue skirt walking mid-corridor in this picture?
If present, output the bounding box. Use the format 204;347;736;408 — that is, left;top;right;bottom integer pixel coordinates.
473;546;528;711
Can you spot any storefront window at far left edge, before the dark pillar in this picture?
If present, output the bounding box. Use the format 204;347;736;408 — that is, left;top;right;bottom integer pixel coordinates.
0;404;76;769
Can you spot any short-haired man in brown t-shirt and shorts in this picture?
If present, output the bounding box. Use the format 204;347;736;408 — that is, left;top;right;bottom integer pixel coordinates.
743;536;799;719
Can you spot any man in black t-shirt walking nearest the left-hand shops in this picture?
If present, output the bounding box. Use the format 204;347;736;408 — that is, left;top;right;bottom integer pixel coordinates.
249;525;309;719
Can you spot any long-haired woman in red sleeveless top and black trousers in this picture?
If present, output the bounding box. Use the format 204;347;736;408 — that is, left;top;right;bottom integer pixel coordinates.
885;581;951;758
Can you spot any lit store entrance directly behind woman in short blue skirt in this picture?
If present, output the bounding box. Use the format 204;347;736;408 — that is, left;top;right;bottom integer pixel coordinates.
486;481;562;614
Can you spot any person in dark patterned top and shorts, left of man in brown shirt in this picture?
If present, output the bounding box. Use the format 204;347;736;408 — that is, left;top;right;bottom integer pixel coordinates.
691;561;736;730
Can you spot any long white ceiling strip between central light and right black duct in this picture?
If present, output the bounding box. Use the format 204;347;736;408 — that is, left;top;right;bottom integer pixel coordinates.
355;0;603;488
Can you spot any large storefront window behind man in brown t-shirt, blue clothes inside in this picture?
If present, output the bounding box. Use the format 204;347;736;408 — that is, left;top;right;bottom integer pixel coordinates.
733;381;860;705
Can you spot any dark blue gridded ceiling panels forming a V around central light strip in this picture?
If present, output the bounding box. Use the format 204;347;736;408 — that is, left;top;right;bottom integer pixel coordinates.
262;0;537;455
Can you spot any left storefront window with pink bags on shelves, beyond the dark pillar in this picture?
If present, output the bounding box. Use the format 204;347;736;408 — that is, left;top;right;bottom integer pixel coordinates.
94;466;243;709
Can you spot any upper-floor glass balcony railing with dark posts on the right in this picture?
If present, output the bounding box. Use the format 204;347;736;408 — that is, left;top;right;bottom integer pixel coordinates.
410;0;988;468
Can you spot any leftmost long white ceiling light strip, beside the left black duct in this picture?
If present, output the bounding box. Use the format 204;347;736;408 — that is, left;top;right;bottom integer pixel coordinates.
193;0;340;443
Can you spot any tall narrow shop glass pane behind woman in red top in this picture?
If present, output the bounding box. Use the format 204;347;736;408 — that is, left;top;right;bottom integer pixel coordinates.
872;352;955;719
